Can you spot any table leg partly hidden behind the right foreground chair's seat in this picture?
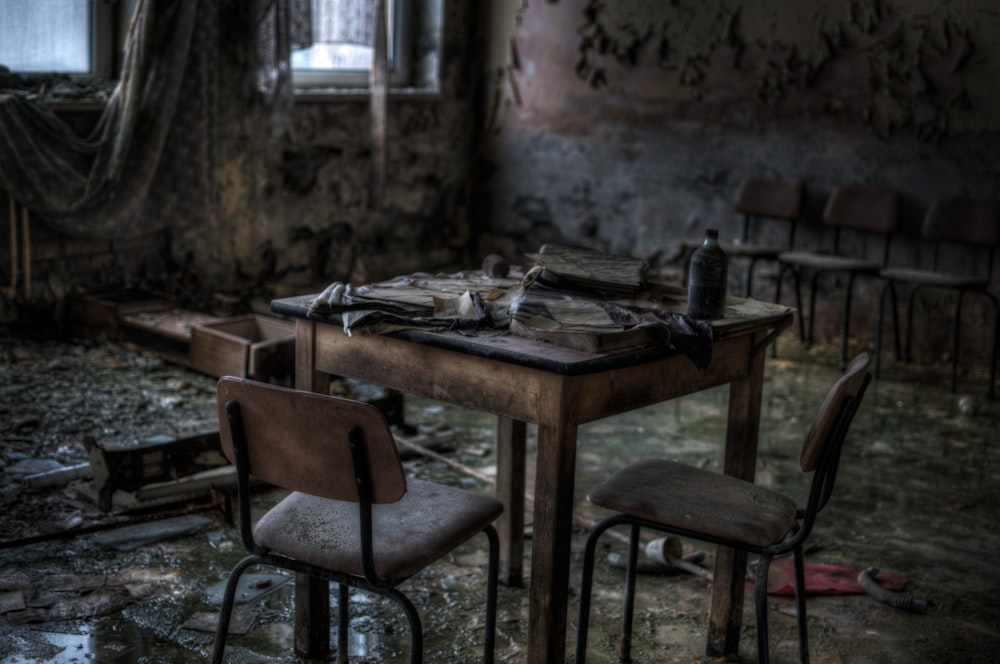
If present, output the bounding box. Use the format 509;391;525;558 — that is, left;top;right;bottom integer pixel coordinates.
706;339;765;657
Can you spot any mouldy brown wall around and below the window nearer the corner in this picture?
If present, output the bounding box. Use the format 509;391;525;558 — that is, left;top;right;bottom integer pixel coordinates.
166;0;476;298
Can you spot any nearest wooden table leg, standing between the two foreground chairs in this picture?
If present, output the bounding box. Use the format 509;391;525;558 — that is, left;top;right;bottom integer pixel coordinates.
527;384;577;664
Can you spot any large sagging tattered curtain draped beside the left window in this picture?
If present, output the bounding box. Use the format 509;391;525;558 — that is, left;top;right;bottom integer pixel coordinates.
0;0;219;239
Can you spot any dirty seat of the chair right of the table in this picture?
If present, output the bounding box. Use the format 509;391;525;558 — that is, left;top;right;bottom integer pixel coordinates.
588;459;797;547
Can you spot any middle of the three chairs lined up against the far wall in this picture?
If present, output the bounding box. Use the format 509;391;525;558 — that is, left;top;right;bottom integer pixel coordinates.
778;185;899;369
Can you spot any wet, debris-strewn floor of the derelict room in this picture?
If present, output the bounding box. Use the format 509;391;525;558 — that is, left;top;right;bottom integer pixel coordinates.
0;332;1000;664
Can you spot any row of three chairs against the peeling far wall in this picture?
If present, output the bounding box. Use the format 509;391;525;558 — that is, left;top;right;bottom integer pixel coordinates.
696;177;1000;398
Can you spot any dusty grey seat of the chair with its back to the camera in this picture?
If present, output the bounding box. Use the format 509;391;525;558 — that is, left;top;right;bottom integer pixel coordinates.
254;479;503;581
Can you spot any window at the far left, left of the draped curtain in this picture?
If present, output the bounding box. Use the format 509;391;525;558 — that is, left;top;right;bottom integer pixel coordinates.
0;0;136;78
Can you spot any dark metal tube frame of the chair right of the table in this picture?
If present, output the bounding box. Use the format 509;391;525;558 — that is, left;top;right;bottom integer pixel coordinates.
576;354;872;664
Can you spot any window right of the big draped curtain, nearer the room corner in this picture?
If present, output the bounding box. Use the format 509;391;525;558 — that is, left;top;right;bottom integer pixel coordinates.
292;0;440;93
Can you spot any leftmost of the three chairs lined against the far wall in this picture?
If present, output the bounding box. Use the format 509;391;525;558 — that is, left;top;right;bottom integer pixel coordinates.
684;177;805;299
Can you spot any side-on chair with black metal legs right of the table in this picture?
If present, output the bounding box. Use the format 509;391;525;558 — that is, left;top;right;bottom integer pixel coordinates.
576;353;871;664
